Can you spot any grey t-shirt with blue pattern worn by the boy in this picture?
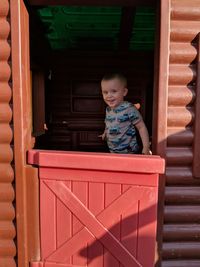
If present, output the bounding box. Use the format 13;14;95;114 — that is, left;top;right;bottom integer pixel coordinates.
105;101;142;153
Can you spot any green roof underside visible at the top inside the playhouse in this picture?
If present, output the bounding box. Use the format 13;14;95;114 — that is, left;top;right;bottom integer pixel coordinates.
37;6;155;50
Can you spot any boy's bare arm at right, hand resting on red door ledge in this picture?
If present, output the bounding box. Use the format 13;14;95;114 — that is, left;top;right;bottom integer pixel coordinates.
135;120;151;155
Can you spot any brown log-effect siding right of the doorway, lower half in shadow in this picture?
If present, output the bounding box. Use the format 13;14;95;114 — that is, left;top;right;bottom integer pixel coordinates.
162;0;200;267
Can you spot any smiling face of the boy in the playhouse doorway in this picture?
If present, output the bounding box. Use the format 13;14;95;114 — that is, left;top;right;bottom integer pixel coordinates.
101;78;128;108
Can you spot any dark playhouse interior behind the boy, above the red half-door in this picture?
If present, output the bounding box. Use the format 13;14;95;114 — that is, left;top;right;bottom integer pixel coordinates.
28;3;156;152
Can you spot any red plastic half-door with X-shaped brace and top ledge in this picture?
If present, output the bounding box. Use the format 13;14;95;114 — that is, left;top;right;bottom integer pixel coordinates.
29;151;163;267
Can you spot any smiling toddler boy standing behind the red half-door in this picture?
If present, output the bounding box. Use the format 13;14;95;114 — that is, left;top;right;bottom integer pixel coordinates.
100;73;151;155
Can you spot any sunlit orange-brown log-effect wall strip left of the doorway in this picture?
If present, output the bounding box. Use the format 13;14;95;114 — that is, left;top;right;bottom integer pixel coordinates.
0;0;16;267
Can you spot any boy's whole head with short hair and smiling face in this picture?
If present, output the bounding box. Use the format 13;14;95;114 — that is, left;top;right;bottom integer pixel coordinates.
101;73;128;108
